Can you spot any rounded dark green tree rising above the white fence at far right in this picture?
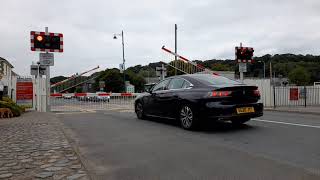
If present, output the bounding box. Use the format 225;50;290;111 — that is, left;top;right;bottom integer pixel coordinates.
289;66;310;86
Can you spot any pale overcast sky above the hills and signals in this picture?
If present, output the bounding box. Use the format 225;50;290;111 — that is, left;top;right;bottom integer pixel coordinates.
0;0;320;76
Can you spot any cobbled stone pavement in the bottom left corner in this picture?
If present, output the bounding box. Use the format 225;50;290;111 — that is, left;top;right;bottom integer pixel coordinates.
0;112;89;180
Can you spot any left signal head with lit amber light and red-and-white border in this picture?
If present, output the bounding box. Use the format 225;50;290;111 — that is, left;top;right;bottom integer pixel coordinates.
30;31;63;52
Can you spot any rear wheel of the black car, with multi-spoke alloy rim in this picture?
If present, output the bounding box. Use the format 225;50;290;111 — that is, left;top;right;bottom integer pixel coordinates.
179;105;197;130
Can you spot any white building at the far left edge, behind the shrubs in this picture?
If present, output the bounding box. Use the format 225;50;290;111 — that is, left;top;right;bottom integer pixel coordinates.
0;57;17;98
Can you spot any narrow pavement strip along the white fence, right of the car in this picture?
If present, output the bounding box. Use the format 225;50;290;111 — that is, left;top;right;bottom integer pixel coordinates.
265;106;320;115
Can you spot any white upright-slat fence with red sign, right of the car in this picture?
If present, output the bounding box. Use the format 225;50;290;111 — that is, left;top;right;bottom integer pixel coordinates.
273;86;320;107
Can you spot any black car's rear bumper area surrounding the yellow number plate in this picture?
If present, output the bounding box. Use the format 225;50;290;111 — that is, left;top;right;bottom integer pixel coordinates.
199;102;263;120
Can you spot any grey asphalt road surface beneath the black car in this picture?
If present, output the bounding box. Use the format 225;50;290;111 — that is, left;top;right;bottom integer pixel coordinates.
59;111;320;180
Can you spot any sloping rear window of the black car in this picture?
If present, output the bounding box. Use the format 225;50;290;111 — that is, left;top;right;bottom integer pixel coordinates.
192;74;241;85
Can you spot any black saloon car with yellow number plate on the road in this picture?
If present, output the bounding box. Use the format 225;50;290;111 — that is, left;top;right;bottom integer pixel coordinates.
135;74;263;129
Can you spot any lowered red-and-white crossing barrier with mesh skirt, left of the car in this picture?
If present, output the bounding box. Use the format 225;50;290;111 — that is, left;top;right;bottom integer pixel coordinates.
50;93;140;112
